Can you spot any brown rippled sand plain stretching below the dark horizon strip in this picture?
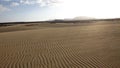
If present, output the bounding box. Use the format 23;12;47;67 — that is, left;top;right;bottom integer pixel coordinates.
0;21;120;68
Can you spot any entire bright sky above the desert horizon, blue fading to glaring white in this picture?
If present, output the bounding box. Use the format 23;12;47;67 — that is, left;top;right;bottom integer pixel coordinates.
0;0;120;22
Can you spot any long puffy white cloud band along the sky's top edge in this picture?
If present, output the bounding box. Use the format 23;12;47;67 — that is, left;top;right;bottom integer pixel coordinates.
3;0;60;7
